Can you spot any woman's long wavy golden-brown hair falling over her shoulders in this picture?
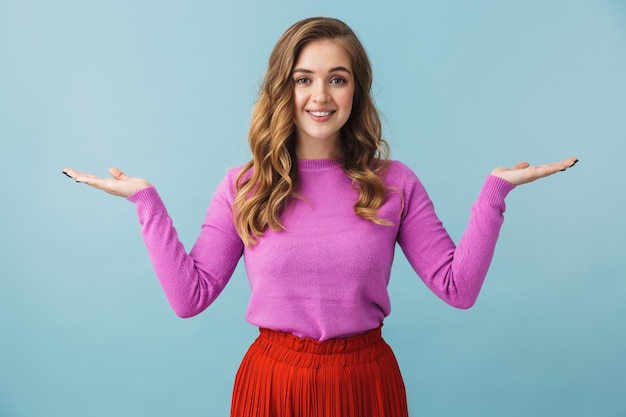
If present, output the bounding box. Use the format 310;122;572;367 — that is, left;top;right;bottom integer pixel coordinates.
233;17;390;246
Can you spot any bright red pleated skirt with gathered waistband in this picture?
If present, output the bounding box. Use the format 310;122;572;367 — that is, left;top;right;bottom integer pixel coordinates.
230;327;408;417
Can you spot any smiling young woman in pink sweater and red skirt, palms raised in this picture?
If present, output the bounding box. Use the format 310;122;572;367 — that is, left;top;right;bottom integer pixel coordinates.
63;18;577;417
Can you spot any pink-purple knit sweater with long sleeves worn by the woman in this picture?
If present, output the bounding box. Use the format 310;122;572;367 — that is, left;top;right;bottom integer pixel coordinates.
129;160;514;340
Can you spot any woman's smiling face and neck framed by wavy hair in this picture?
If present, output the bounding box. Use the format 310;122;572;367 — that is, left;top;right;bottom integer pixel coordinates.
292;39;354;159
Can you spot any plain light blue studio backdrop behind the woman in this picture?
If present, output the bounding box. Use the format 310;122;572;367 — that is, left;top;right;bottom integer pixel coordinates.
0;0;626;417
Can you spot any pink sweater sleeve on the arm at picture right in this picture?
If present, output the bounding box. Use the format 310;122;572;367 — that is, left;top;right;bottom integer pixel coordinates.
398;168;515;308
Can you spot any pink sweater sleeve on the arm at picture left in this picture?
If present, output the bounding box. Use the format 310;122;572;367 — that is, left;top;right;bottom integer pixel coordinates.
128;171;243;318
